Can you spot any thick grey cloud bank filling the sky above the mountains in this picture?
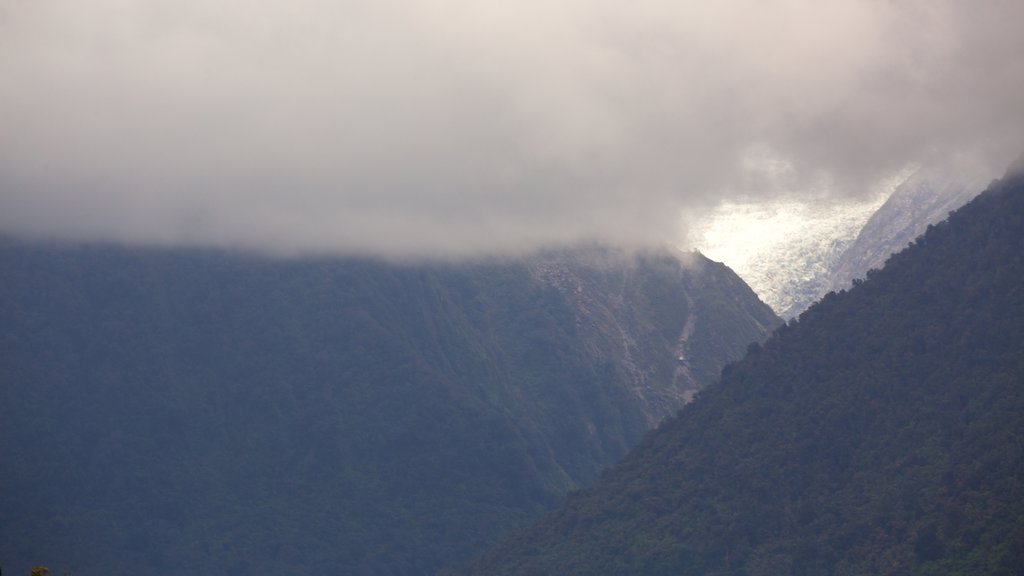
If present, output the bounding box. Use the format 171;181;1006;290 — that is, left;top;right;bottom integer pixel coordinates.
0;0;1024;257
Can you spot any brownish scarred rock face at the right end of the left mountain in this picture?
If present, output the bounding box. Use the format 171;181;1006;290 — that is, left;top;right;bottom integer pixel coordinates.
527;247;780;426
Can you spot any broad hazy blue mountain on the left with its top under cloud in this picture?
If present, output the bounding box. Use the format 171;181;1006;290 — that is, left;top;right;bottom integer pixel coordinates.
0;241;778;575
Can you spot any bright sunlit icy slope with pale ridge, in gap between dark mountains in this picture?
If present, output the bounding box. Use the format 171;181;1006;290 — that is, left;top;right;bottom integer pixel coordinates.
691;160;986;319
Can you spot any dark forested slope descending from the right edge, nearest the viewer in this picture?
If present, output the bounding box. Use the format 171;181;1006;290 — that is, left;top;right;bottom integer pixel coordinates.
449;166;1024;576
